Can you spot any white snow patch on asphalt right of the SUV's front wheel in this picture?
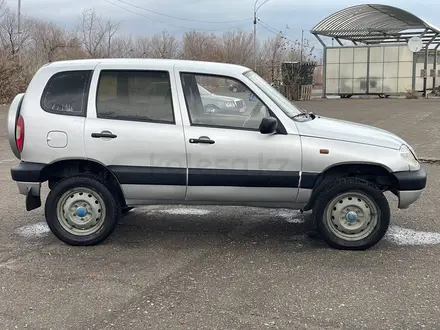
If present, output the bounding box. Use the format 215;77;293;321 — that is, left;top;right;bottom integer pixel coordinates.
385;226;440;245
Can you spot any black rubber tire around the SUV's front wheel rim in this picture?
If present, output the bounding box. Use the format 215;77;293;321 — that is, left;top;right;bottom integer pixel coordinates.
312;177;390;250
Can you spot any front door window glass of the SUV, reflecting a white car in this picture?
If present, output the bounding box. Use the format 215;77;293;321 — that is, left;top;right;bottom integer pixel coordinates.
181;73;269;130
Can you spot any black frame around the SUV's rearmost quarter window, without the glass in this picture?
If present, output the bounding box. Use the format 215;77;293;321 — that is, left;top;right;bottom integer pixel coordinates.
40;69;93;117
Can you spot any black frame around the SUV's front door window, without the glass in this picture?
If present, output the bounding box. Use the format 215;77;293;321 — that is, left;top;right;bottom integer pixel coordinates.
179;70;287;135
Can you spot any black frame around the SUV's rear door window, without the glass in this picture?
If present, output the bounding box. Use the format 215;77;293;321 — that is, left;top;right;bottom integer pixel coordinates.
95;68;176;125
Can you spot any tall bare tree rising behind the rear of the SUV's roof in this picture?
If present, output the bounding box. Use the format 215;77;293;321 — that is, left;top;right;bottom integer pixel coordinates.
78;9;119;58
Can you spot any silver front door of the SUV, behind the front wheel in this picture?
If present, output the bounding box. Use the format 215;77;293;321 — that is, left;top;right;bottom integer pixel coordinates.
175;70;301;204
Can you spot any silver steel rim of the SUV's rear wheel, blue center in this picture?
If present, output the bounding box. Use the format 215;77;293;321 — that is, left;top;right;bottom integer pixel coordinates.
57;187;106;236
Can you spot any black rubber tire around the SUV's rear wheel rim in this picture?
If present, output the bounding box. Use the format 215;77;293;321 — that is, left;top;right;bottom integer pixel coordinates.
45;174;121;246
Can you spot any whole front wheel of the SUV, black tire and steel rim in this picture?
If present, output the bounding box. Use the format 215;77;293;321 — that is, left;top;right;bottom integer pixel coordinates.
313;178;390;250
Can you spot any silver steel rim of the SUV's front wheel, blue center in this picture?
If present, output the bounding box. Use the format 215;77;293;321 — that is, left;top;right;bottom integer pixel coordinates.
325;192;380;241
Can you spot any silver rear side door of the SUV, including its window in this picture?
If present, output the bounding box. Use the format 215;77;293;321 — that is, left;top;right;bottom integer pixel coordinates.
84;63;187;204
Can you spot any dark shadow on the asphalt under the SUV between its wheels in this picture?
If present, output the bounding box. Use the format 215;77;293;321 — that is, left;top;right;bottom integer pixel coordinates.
108;207;342;248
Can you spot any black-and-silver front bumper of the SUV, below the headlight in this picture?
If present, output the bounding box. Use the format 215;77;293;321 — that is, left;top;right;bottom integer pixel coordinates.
393;167;427;209
